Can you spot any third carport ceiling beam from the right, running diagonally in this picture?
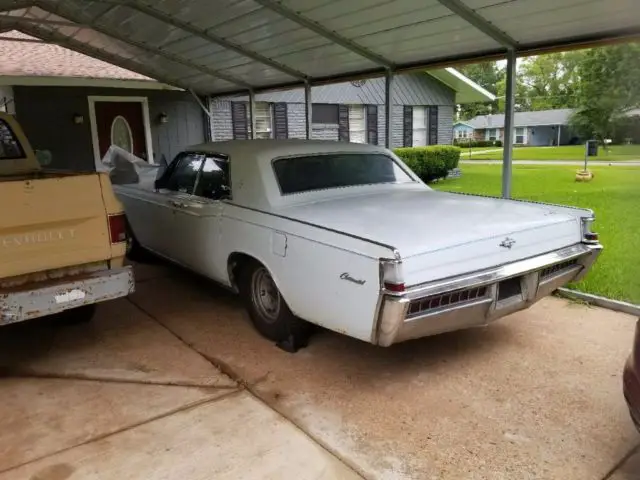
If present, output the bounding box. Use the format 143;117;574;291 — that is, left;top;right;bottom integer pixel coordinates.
101;0;307;80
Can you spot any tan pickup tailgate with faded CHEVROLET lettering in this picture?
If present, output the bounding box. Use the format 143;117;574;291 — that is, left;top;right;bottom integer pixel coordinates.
0;173;111;278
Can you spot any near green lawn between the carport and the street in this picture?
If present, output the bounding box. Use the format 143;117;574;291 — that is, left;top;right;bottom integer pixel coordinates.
432;164;640;304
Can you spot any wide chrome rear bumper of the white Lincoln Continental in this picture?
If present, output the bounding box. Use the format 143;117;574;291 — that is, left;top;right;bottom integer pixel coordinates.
373;243;602;347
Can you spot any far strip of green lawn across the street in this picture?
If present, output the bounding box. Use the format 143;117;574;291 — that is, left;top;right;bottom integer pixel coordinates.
460;145;640;161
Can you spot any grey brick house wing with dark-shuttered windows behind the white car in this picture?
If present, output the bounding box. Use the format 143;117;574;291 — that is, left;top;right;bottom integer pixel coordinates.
210;68;494;147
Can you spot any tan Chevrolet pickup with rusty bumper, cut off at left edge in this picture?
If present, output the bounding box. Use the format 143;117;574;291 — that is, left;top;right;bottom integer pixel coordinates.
0;112;134;325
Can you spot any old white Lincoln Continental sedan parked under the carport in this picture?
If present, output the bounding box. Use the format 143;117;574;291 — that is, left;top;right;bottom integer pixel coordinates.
115;140;602;350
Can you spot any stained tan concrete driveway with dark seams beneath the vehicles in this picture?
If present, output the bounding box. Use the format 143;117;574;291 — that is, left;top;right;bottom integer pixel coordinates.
0;265;640;480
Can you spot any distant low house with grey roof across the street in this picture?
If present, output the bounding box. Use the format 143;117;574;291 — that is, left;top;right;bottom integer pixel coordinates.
467;108;577;146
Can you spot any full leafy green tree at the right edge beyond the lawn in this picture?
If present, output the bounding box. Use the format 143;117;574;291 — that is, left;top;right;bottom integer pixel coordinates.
571;44;640;143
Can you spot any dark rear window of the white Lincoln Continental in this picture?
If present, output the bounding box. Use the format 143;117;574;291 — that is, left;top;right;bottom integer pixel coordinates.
273;153;414;195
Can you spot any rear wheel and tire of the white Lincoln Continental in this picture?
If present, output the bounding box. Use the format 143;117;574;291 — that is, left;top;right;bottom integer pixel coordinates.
238;262;311;352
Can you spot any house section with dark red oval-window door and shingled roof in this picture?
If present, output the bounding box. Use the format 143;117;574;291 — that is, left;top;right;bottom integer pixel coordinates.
0;32;208;169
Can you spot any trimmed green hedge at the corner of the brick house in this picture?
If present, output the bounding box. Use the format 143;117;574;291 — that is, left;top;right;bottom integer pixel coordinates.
394;145;460;183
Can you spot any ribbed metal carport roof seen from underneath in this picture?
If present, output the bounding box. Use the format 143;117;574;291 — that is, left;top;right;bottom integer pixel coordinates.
0;0;640;95
